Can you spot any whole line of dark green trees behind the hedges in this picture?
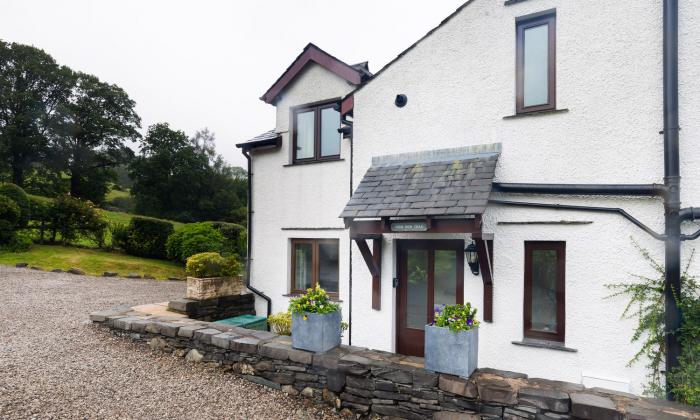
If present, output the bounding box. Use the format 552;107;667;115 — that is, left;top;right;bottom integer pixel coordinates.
0;40;247;223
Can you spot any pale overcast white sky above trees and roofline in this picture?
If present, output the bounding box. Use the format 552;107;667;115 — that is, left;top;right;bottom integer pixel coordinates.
0;0;464;166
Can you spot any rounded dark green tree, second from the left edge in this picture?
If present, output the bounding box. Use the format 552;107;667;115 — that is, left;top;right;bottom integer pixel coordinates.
52;73;141;203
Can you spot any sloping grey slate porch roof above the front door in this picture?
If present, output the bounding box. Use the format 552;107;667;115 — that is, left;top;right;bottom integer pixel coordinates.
340;144;501;218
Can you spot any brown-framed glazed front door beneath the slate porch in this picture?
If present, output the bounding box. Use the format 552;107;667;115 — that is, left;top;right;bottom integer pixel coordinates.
396;240;464;356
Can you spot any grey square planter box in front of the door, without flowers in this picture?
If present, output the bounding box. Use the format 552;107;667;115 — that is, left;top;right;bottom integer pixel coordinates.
425;325;479;378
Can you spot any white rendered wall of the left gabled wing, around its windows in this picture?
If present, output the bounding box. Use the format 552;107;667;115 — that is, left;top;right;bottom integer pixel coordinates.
251;64;352;339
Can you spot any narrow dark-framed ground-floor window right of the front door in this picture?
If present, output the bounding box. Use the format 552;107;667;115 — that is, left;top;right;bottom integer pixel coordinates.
523;241;566;343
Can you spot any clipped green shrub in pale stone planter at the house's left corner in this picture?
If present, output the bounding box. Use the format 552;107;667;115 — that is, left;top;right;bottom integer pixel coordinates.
185;252;245;300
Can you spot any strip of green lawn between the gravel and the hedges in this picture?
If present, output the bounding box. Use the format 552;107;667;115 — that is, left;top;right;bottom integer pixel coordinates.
0;245;185;279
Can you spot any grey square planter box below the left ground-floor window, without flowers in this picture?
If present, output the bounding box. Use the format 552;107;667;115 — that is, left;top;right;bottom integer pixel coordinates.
292;311;342;353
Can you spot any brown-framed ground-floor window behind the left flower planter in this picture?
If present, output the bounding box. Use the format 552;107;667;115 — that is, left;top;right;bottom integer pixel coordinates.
291;239;339;297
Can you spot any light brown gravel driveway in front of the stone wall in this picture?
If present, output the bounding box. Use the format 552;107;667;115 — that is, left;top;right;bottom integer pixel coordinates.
0;266;342;419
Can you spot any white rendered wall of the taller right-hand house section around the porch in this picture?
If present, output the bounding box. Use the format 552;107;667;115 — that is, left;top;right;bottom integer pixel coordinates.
352;0;700;393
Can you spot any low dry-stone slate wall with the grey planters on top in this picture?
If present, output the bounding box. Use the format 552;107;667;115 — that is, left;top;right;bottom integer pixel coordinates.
90;308;700;420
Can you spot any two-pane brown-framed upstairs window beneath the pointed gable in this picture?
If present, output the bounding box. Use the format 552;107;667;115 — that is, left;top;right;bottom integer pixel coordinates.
293;102;340;163
